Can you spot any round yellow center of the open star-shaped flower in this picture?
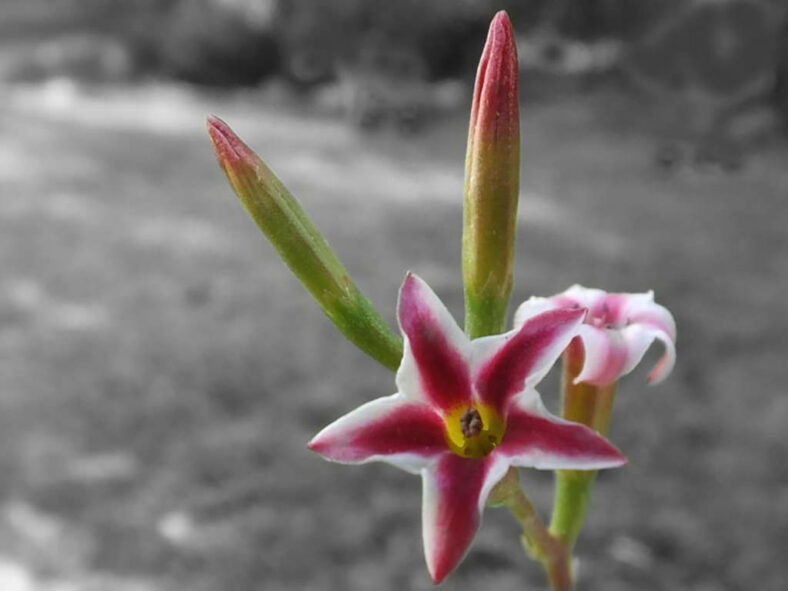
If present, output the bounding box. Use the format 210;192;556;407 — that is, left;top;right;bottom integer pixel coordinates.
444;404;506;458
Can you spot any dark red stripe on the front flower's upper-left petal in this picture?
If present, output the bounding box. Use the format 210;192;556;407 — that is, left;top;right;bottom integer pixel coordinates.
399;275;471;411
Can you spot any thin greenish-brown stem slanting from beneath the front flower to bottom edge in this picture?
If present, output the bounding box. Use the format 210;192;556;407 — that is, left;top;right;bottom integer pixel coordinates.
488;468;573;591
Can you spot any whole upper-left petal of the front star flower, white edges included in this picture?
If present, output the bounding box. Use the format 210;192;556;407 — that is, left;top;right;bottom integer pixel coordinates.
397;273;471;411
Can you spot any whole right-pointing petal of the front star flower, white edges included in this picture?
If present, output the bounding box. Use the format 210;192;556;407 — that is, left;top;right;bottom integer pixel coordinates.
492;389;627;470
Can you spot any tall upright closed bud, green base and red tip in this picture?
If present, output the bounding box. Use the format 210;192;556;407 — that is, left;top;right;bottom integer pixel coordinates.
462;11;520;338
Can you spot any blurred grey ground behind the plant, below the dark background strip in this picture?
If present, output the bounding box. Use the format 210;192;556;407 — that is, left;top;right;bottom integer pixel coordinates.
0;80;788;591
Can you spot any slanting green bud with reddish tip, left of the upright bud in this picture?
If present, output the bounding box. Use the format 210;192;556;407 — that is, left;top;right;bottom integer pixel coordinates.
208;117;402;370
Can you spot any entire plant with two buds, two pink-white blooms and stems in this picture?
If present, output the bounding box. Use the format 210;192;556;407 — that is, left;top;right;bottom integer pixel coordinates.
208;5;676;591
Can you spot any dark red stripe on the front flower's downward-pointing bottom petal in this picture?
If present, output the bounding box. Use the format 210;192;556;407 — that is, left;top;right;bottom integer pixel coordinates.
424;454;492;583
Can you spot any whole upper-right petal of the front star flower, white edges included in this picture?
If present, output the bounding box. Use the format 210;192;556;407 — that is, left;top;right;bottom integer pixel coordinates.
473;309;586;416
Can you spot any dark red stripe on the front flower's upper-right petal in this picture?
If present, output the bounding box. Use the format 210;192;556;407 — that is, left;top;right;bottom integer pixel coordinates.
476;308;586;417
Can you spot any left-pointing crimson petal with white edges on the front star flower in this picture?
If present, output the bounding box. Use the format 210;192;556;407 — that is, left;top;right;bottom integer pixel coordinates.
309;394;449;473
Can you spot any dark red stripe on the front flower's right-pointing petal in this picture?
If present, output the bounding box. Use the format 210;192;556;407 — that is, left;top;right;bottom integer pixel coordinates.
495;408;626;469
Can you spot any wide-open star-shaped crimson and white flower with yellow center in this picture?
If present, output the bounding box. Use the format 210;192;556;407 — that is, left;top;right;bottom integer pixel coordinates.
309;274;626;582
